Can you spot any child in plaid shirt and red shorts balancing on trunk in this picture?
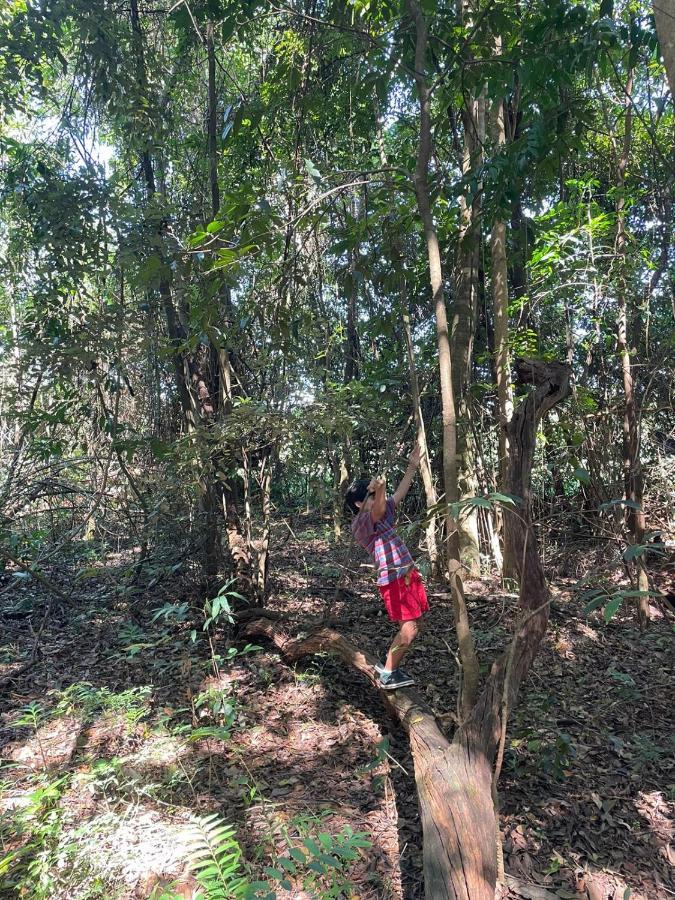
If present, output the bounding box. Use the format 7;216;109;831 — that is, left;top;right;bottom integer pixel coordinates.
345;445;429;691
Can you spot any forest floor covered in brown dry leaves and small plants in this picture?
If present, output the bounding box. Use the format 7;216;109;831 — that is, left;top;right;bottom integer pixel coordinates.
0;520;675;900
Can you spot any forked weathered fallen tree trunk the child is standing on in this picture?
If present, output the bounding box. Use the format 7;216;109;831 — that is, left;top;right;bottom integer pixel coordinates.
244;360;569;900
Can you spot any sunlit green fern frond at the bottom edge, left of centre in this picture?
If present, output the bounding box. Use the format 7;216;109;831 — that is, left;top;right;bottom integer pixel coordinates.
190;813;249;900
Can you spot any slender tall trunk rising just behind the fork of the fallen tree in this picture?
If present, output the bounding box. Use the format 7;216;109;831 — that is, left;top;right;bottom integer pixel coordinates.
406;0;479;714
